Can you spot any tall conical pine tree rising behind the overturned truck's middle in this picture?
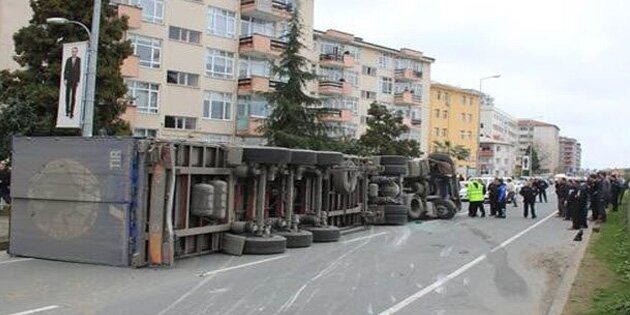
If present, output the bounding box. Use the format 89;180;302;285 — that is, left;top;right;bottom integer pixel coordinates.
261;8;330;149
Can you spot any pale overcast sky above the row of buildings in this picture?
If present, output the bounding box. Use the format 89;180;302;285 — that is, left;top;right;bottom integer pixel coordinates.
313;0;630;169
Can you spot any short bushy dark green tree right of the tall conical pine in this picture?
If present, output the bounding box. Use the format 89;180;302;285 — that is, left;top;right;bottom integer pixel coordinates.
357;102;422;157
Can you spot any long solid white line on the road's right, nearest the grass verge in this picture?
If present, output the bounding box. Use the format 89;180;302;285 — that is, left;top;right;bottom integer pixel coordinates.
380;211;558;315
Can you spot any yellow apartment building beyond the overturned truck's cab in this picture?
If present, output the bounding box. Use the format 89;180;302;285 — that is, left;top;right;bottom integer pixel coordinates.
428;82;480;175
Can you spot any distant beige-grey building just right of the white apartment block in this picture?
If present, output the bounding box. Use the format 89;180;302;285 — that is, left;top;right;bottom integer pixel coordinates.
518;119;560;173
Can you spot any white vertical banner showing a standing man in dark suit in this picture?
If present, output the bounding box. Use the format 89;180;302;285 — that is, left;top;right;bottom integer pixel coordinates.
57;42;88;128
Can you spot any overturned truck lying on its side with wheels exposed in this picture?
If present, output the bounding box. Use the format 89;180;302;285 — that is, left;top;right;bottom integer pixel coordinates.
9;137;461;267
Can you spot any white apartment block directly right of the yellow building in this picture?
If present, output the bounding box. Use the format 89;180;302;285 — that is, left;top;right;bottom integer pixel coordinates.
479;98;518;176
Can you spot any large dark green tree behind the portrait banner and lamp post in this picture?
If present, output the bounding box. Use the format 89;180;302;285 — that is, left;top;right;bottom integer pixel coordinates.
0;0;132;158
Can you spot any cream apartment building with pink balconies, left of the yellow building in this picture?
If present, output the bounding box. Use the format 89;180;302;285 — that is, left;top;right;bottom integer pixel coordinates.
314;30;435;152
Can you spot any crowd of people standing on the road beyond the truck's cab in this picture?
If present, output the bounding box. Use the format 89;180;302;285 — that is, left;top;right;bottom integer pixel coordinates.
466;172;628;230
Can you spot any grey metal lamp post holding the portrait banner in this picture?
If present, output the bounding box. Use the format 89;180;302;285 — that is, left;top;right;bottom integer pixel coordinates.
46;0;101;137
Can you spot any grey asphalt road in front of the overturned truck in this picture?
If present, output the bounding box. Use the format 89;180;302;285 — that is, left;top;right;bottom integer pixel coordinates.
0;200;585;315
